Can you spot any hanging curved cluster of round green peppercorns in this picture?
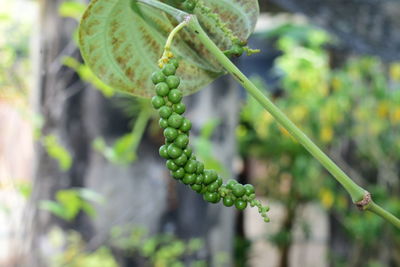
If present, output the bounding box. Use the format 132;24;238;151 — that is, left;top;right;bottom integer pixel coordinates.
151;58;269;222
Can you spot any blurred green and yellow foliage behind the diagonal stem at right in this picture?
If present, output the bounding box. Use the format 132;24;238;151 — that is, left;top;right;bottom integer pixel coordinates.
237;25;400;264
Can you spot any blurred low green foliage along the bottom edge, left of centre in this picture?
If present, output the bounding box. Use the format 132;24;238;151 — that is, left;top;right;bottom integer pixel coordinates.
49;226;207;267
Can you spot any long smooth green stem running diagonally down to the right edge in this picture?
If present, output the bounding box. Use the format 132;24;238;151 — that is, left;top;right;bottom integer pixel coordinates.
188;15;400;228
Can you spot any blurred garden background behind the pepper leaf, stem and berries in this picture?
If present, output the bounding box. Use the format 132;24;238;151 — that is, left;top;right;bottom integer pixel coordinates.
0;0;400;267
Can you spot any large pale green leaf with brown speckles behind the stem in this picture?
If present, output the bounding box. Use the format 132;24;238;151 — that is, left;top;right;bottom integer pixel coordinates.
79;0;259;97
